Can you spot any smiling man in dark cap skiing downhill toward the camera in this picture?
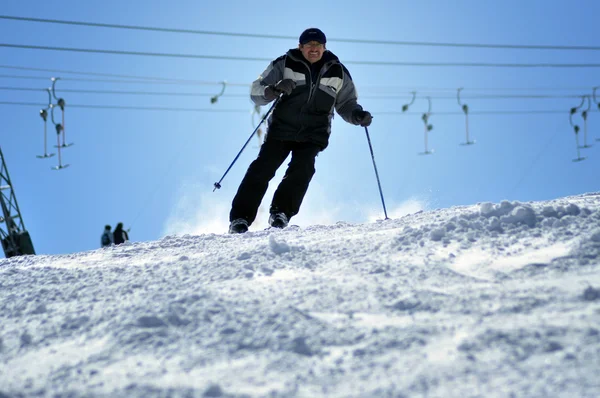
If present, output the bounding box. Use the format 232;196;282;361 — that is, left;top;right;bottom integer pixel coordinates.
229;28;372;233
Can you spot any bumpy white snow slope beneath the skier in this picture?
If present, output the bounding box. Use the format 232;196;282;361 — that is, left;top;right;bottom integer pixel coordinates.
0;193;600;398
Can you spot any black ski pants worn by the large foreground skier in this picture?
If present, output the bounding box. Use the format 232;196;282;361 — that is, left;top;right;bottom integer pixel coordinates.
229;138;321;224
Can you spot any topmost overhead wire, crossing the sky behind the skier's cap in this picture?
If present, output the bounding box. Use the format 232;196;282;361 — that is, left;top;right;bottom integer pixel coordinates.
0;15;600;51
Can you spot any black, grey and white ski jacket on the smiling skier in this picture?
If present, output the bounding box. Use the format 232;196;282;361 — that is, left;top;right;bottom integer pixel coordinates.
250;49;362;150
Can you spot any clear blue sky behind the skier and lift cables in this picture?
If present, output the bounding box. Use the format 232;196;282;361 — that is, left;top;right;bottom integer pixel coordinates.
0;1;600;254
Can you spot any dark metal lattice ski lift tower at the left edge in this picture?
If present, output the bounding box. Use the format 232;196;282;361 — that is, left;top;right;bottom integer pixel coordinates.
0;148;35;258
